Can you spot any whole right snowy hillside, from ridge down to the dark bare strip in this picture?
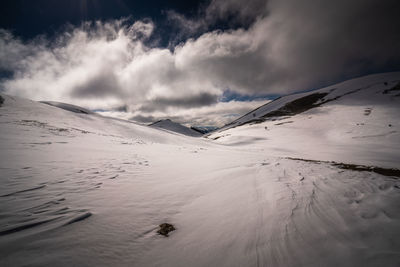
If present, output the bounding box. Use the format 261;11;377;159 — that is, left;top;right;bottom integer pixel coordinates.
209;72;400;168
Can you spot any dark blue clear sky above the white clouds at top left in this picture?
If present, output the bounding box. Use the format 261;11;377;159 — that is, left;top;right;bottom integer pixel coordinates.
0;0;209;44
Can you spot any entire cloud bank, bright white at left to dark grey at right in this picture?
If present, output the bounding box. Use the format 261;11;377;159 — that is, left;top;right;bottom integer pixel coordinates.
0;0;400;125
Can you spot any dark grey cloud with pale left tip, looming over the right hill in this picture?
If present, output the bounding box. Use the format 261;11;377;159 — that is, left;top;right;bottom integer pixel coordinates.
174;0;400;93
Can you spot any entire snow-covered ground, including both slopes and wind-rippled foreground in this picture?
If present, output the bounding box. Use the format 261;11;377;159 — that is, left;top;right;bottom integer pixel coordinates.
0;73;400;266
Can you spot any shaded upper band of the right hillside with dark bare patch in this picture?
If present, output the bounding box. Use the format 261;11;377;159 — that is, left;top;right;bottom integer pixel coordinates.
221;72;400;130
